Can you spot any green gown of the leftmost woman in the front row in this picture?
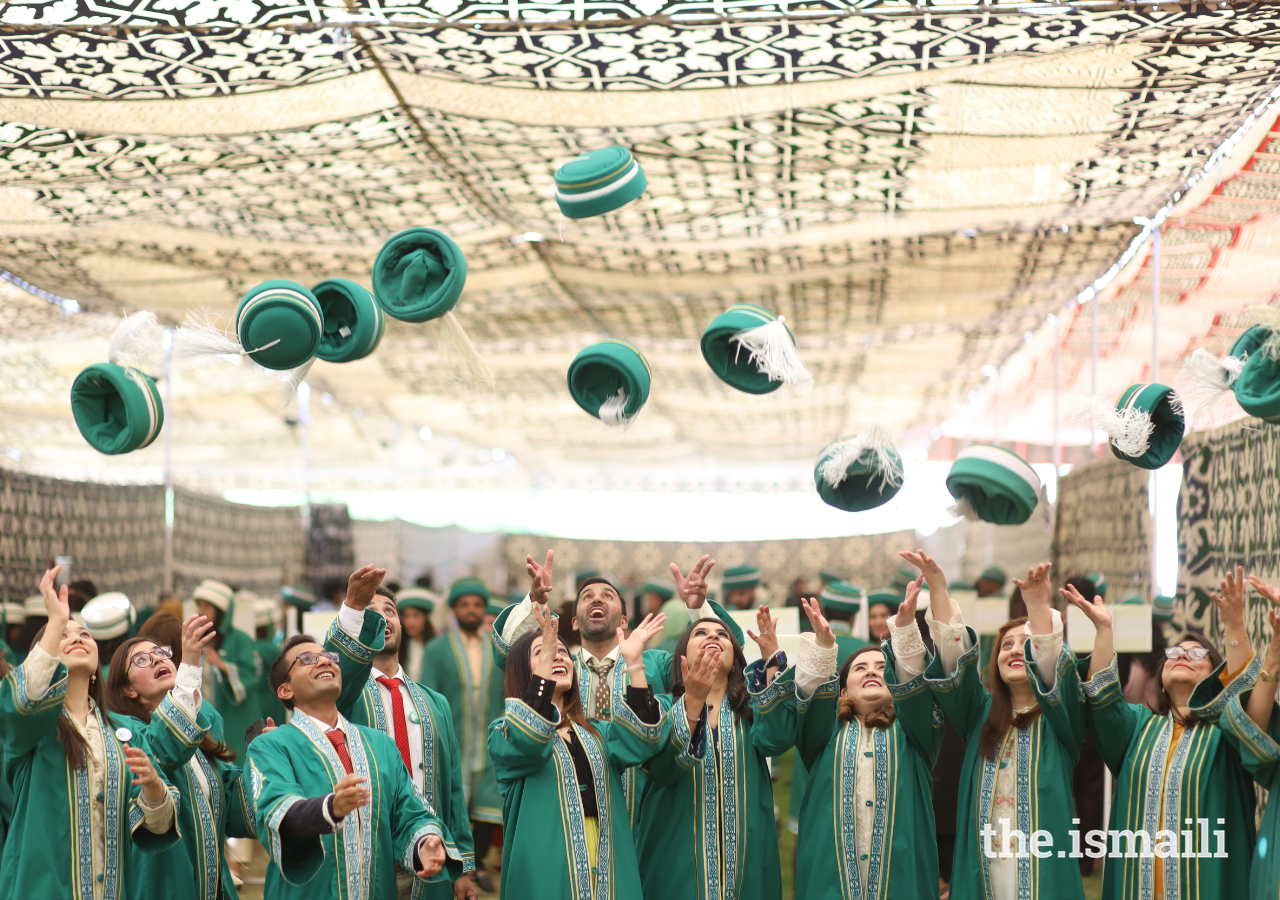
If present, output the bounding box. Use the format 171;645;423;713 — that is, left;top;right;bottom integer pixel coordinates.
0;663;180;900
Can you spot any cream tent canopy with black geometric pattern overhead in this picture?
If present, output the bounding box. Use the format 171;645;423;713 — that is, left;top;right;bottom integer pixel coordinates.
0;0;1280;485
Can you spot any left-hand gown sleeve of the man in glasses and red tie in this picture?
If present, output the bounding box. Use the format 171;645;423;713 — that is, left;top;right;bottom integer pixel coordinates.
244;731;328;886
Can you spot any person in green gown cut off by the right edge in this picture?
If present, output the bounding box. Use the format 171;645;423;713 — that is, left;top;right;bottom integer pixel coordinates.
1183;575;1280;900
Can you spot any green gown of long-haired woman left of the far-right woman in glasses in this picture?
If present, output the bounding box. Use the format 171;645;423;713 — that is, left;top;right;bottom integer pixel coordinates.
924;627;1085;900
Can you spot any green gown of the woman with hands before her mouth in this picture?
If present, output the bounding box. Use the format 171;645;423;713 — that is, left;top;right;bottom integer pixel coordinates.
635;663;795;900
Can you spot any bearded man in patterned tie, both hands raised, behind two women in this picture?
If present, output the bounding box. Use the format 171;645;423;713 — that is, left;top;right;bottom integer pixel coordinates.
494;550;742;827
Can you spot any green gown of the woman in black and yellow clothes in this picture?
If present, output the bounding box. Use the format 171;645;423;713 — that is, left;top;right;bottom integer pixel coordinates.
489;698;662;900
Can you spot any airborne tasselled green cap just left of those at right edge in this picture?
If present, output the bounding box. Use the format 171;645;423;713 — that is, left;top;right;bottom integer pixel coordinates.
1088;384;1184;469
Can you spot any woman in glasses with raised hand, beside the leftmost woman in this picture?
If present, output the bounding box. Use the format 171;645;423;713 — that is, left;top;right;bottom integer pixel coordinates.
106;613;257;900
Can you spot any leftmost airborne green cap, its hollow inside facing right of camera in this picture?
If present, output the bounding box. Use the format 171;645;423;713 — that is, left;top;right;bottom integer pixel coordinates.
72;362;164;456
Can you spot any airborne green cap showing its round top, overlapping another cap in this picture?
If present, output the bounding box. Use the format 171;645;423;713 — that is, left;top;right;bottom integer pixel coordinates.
236;280;324;371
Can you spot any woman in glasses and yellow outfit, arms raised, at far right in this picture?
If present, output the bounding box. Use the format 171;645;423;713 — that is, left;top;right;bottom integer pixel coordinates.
1062;570;1261;900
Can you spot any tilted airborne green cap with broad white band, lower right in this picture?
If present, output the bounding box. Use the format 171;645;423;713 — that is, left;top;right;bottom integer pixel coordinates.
947;444;1041;525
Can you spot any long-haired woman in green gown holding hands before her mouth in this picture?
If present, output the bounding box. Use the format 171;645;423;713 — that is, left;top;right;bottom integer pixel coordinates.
635;594;795;900
